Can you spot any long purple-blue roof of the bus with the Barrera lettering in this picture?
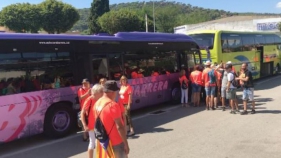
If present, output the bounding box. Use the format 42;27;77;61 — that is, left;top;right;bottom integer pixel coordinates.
0;32;194;42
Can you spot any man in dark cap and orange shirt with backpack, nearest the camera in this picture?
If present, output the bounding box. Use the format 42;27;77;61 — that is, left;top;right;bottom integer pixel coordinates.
94;80;130;158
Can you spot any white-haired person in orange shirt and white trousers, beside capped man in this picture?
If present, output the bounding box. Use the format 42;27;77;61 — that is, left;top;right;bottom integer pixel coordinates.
81;84;103;158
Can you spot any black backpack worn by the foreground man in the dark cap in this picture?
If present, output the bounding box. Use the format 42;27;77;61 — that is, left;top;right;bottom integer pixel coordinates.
94;103;115;142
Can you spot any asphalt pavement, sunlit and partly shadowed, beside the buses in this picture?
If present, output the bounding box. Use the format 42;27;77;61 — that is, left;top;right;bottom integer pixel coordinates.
0;76;281;158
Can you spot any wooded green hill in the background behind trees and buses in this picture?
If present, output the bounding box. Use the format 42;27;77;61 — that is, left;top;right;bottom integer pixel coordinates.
72;1;278;32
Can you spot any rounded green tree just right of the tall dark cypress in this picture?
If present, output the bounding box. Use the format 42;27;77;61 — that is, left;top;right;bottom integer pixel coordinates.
98;9;144;34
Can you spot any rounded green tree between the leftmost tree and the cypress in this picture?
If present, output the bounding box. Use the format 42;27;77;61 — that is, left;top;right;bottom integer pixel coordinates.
40;0;80;34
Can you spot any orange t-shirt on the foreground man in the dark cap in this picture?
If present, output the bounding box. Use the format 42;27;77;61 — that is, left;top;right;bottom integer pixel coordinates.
95;98;124;146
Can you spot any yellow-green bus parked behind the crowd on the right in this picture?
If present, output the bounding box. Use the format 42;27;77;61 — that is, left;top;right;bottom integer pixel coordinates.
187;30;281;79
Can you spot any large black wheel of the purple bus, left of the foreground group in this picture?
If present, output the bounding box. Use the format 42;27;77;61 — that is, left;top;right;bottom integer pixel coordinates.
44;103;74;138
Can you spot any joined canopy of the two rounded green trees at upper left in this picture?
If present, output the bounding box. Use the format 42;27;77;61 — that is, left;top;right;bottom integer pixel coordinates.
0;0;79;33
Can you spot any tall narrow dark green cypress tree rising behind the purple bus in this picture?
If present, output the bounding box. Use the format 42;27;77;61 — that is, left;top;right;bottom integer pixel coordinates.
88;0;109;34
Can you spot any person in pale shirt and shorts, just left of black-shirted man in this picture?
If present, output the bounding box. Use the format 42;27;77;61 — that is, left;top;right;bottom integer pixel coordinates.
225;64;238;114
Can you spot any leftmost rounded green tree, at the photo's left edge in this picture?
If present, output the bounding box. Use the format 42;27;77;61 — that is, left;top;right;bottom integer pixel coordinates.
0;3;42;33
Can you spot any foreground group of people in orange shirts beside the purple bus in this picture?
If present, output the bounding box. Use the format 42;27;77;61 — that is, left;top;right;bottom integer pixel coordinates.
78;76;135;158
